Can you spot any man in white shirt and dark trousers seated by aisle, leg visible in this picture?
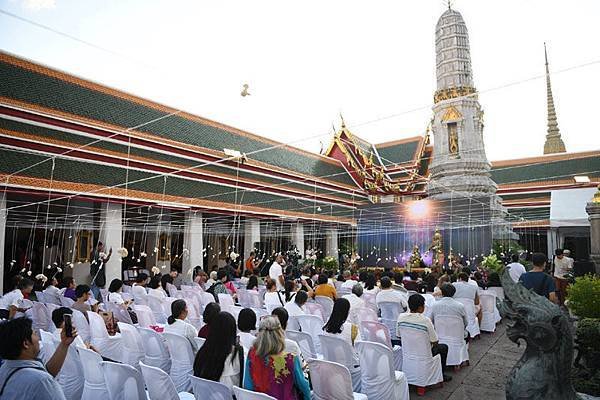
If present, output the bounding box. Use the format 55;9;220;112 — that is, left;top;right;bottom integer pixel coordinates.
396;294;450;382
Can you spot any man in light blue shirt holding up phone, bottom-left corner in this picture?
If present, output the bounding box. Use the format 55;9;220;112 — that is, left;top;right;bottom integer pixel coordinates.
0;317;77;400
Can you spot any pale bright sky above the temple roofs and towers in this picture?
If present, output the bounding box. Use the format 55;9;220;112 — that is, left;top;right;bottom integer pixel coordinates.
0;0;600;160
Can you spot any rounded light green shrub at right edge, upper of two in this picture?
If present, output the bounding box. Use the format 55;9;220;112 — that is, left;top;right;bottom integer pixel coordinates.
567;275;600;318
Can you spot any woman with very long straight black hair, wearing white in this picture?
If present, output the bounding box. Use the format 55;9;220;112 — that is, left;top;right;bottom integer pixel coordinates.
194;312;244;388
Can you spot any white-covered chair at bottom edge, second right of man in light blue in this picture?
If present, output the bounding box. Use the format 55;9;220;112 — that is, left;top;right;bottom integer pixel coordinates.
101;361;148;400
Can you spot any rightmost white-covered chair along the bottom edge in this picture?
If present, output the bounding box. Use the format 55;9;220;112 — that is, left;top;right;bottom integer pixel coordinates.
354;340;409;400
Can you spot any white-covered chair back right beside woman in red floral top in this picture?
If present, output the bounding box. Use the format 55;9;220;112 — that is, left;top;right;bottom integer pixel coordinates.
308;359;368;400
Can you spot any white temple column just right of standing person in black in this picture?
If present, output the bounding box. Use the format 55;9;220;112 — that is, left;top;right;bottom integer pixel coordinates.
100;203;123;288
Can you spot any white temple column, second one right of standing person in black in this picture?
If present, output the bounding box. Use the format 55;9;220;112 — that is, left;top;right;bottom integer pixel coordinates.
181;211;204;282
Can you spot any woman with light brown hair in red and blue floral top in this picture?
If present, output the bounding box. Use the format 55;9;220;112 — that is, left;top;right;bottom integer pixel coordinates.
244;316;310;400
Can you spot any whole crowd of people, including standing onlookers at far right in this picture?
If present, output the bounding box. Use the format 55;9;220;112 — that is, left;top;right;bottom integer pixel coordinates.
0;244;572;399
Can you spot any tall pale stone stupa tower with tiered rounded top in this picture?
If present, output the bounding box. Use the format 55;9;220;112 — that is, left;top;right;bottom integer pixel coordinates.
427;7;496;199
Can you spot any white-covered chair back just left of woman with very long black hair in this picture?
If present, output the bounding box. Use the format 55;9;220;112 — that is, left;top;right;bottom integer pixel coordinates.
163;332;194;392
